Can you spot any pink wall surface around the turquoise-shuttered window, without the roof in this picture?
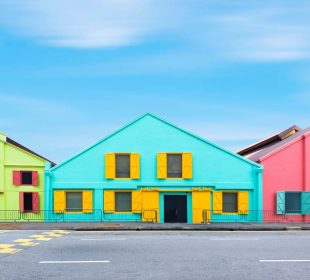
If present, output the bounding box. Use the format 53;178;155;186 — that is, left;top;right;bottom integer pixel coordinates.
260;133;310;222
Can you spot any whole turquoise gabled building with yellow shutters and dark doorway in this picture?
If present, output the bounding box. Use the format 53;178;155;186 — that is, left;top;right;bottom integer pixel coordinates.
45;114;262;223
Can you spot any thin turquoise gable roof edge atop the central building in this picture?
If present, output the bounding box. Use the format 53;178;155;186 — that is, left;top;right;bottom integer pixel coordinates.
52;113;262;170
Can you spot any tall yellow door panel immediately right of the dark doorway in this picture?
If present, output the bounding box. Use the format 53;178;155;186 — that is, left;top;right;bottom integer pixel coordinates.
192;191;211;224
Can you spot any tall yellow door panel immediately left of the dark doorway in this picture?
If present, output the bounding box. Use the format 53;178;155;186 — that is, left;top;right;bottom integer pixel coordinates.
142;191;159;222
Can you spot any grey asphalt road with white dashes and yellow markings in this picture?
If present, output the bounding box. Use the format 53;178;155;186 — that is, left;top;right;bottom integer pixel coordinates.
0;230;310;280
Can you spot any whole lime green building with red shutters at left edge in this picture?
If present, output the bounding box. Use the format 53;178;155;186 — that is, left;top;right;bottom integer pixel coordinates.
0;133;54;221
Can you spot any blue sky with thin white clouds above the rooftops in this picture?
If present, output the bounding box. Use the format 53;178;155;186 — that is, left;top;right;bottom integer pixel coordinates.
0;0;310;162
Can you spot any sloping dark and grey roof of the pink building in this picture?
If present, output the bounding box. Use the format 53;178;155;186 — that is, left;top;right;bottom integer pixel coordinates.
238;125;310;162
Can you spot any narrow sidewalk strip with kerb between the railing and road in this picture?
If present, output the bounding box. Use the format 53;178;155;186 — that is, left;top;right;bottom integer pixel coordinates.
0;222;310;231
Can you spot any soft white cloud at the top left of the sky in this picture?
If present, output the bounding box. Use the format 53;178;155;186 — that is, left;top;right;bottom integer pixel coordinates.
0;0;174;48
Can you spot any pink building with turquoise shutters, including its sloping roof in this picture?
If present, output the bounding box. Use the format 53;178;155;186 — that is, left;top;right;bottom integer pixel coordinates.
238;126;310;222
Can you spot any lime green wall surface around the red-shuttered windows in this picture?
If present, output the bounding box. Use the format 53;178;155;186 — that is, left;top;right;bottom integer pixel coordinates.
0;133;45;210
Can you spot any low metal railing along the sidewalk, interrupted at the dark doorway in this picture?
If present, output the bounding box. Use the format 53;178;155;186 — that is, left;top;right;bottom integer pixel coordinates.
0;209;310;223
